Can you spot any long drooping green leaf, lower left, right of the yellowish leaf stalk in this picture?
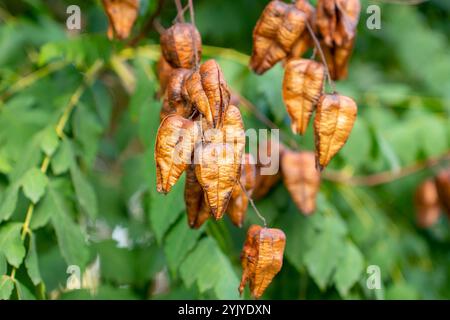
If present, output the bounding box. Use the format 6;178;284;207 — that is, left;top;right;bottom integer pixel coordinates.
48;180;89;268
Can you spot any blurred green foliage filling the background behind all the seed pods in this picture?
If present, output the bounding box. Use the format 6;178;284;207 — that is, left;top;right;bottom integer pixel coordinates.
0;0;450;299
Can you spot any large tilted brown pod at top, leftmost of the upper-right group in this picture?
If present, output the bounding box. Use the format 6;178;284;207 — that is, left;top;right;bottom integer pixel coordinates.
250;0;308;74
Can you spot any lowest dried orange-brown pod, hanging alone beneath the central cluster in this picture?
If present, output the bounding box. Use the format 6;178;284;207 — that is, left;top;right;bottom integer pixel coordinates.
239;226;286;299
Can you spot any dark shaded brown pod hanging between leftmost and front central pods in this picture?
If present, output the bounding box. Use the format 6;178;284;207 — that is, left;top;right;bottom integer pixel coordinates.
184;165;211;229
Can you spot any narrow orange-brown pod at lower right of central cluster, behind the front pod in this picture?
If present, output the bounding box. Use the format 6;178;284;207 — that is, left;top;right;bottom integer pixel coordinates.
227;153;256;228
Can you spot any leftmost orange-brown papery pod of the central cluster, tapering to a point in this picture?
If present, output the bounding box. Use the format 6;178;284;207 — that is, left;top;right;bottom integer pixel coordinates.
155;115;198;193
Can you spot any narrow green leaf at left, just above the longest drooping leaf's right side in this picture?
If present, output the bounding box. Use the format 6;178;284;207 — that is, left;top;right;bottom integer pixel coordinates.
70;163;98;219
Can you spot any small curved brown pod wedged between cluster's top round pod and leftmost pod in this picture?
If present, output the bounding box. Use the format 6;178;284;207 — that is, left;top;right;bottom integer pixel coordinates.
166;68;194;118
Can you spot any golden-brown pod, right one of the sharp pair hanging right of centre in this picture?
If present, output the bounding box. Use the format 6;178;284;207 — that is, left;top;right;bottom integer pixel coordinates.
314;94;358;171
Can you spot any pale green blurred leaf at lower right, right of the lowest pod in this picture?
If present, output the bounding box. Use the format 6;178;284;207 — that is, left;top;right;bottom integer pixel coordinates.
334;241;364;297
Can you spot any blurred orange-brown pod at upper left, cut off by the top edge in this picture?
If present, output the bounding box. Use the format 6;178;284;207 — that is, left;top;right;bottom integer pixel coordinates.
102;0;139;39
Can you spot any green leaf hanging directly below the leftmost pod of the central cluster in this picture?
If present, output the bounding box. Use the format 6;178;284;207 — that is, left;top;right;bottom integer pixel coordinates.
149;175;185;242
